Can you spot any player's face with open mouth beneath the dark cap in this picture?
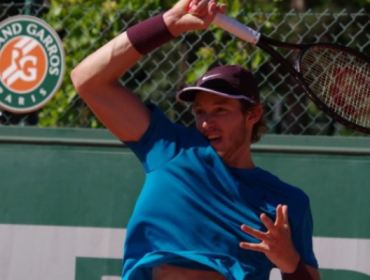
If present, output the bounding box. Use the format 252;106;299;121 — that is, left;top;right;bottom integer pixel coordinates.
193;92;253;166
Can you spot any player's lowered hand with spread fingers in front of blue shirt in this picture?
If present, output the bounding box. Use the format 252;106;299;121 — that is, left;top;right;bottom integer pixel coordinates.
240;205;320;280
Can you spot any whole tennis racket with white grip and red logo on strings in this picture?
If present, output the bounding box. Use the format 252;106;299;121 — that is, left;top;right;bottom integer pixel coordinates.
194;6;370;134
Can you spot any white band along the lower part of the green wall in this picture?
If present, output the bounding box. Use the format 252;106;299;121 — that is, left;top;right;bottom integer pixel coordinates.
0;224;370;280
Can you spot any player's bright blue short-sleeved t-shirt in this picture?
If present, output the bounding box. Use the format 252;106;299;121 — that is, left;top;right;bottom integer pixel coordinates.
122;106;317;280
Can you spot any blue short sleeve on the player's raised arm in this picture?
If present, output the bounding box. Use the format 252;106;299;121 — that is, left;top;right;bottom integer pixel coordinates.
124;104;179;173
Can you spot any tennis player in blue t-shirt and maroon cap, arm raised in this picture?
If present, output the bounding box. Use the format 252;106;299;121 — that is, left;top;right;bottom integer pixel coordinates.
71;0;320;280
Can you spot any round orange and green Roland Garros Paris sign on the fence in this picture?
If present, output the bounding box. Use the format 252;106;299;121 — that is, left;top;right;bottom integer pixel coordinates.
0;16;65;113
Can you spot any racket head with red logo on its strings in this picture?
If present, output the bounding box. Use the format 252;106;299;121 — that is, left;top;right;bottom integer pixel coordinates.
295;43;370;134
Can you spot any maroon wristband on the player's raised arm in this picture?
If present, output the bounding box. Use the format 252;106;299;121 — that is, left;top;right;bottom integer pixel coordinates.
126;13;175;55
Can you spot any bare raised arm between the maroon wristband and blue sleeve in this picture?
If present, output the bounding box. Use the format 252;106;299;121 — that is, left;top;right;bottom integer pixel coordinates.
71;32;145;141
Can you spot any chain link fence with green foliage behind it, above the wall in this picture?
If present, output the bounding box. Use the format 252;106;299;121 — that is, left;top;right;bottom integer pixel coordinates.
0;1;370;135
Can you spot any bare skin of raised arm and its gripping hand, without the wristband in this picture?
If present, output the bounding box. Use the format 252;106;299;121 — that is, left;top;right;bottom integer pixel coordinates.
71;0;225;142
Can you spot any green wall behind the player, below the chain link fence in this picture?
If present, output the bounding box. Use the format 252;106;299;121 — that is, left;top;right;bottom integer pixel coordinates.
0;127;370;280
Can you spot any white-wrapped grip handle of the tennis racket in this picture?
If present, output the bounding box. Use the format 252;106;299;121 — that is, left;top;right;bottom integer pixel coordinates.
213;14;261;45
